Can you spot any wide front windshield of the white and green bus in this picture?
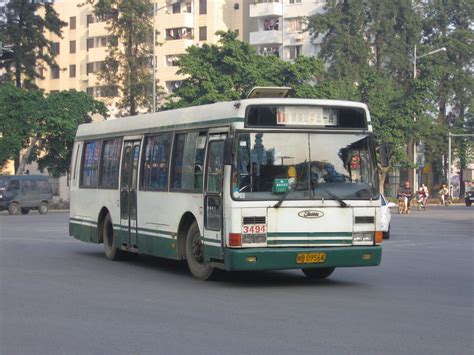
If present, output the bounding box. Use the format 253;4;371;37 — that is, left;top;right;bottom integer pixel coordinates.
233;132;379;200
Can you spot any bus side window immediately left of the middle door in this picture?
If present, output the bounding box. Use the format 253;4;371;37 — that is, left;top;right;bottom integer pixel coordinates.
100;138;122;189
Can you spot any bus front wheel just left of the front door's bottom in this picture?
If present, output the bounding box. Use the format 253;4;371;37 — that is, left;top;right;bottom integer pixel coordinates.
186;222;214;280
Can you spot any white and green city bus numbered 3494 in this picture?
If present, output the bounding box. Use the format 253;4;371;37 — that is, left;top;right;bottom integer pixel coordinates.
69;90;382;279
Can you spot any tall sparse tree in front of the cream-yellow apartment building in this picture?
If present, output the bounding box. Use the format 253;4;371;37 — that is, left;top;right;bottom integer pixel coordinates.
87;0;160;116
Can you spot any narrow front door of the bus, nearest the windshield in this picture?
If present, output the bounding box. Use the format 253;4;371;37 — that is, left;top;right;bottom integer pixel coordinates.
203;133;227;261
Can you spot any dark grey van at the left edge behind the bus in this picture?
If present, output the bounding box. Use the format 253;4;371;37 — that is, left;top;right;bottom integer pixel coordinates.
0;175;53;214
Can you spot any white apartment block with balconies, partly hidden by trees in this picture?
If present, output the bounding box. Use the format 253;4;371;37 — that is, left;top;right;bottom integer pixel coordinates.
249;0;326;60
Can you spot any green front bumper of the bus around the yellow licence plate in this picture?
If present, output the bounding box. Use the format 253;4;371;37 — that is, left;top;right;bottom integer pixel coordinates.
224;246;382;271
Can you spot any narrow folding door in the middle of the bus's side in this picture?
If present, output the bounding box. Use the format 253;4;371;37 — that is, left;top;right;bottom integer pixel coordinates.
120;140;140;248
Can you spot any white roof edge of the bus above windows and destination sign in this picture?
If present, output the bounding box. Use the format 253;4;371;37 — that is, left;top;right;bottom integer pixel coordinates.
76;98;370;140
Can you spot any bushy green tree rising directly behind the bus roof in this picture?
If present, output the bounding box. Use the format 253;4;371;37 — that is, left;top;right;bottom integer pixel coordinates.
163;31;323;109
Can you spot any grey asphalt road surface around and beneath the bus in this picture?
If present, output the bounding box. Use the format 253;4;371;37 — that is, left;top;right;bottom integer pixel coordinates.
0;206;474;355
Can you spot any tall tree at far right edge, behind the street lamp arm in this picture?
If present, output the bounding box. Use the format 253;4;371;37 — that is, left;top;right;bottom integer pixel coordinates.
419;0;474;192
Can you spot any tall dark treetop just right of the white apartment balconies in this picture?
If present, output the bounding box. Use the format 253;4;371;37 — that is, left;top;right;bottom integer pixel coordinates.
307;0;420;82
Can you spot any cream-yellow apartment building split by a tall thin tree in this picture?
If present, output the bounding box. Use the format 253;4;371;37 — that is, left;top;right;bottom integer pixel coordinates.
38;0;245;106
